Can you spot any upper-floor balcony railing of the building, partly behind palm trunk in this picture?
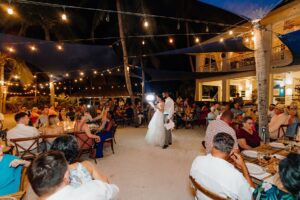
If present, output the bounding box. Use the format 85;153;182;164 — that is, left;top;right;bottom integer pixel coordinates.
200;45;293;72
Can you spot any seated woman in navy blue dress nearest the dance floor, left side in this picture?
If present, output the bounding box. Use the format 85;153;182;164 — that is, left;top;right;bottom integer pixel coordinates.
96;111;115;158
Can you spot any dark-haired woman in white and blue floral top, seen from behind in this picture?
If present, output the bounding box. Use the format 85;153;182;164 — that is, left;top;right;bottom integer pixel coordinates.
51;135;108;187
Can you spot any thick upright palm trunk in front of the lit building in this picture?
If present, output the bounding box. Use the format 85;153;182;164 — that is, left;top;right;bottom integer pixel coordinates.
254;22;272;143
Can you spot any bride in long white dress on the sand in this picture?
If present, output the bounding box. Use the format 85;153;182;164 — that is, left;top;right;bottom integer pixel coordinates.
145;96;165;147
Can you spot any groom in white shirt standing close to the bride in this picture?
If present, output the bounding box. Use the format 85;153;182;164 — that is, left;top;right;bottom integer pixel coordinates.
162;92;174;149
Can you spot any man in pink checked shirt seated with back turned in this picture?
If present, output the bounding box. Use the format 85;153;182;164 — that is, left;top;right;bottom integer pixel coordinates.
204;110;238;153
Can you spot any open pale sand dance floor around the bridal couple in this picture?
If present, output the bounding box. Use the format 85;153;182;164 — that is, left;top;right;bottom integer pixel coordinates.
5;115;204;200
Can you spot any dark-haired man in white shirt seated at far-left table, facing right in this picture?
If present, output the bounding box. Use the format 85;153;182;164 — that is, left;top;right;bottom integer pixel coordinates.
7;112;39;149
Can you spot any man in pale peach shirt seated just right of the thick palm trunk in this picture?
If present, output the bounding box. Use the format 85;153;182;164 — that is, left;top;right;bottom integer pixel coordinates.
269;104;288;139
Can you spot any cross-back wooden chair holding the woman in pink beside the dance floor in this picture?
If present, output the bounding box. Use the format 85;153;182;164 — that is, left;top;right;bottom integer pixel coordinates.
73;132;97;163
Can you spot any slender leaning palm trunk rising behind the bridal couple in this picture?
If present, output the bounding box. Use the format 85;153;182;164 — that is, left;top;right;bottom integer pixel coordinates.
116;0;137;126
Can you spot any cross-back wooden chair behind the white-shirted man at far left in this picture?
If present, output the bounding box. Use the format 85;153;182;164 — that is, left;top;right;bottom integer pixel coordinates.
10;137;39;160
